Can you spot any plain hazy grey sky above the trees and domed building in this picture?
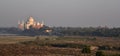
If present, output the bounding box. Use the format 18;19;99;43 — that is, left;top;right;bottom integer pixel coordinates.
0;0;120;27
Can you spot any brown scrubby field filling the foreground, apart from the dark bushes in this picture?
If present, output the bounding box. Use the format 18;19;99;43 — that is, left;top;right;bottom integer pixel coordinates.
0;36;120;56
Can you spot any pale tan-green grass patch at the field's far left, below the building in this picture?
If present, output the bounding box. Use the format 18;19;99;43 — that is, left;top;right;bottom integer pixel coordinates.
0;36;35;44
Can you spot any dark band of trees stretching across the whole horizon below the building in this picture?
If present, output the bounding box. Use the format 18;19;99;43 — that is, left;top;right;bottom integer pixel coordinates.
0;26;120;37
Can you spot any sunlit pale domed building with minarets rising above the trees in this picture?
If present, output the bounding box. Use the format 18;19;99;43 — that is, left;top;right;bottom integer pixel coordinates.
18;16;44;30
